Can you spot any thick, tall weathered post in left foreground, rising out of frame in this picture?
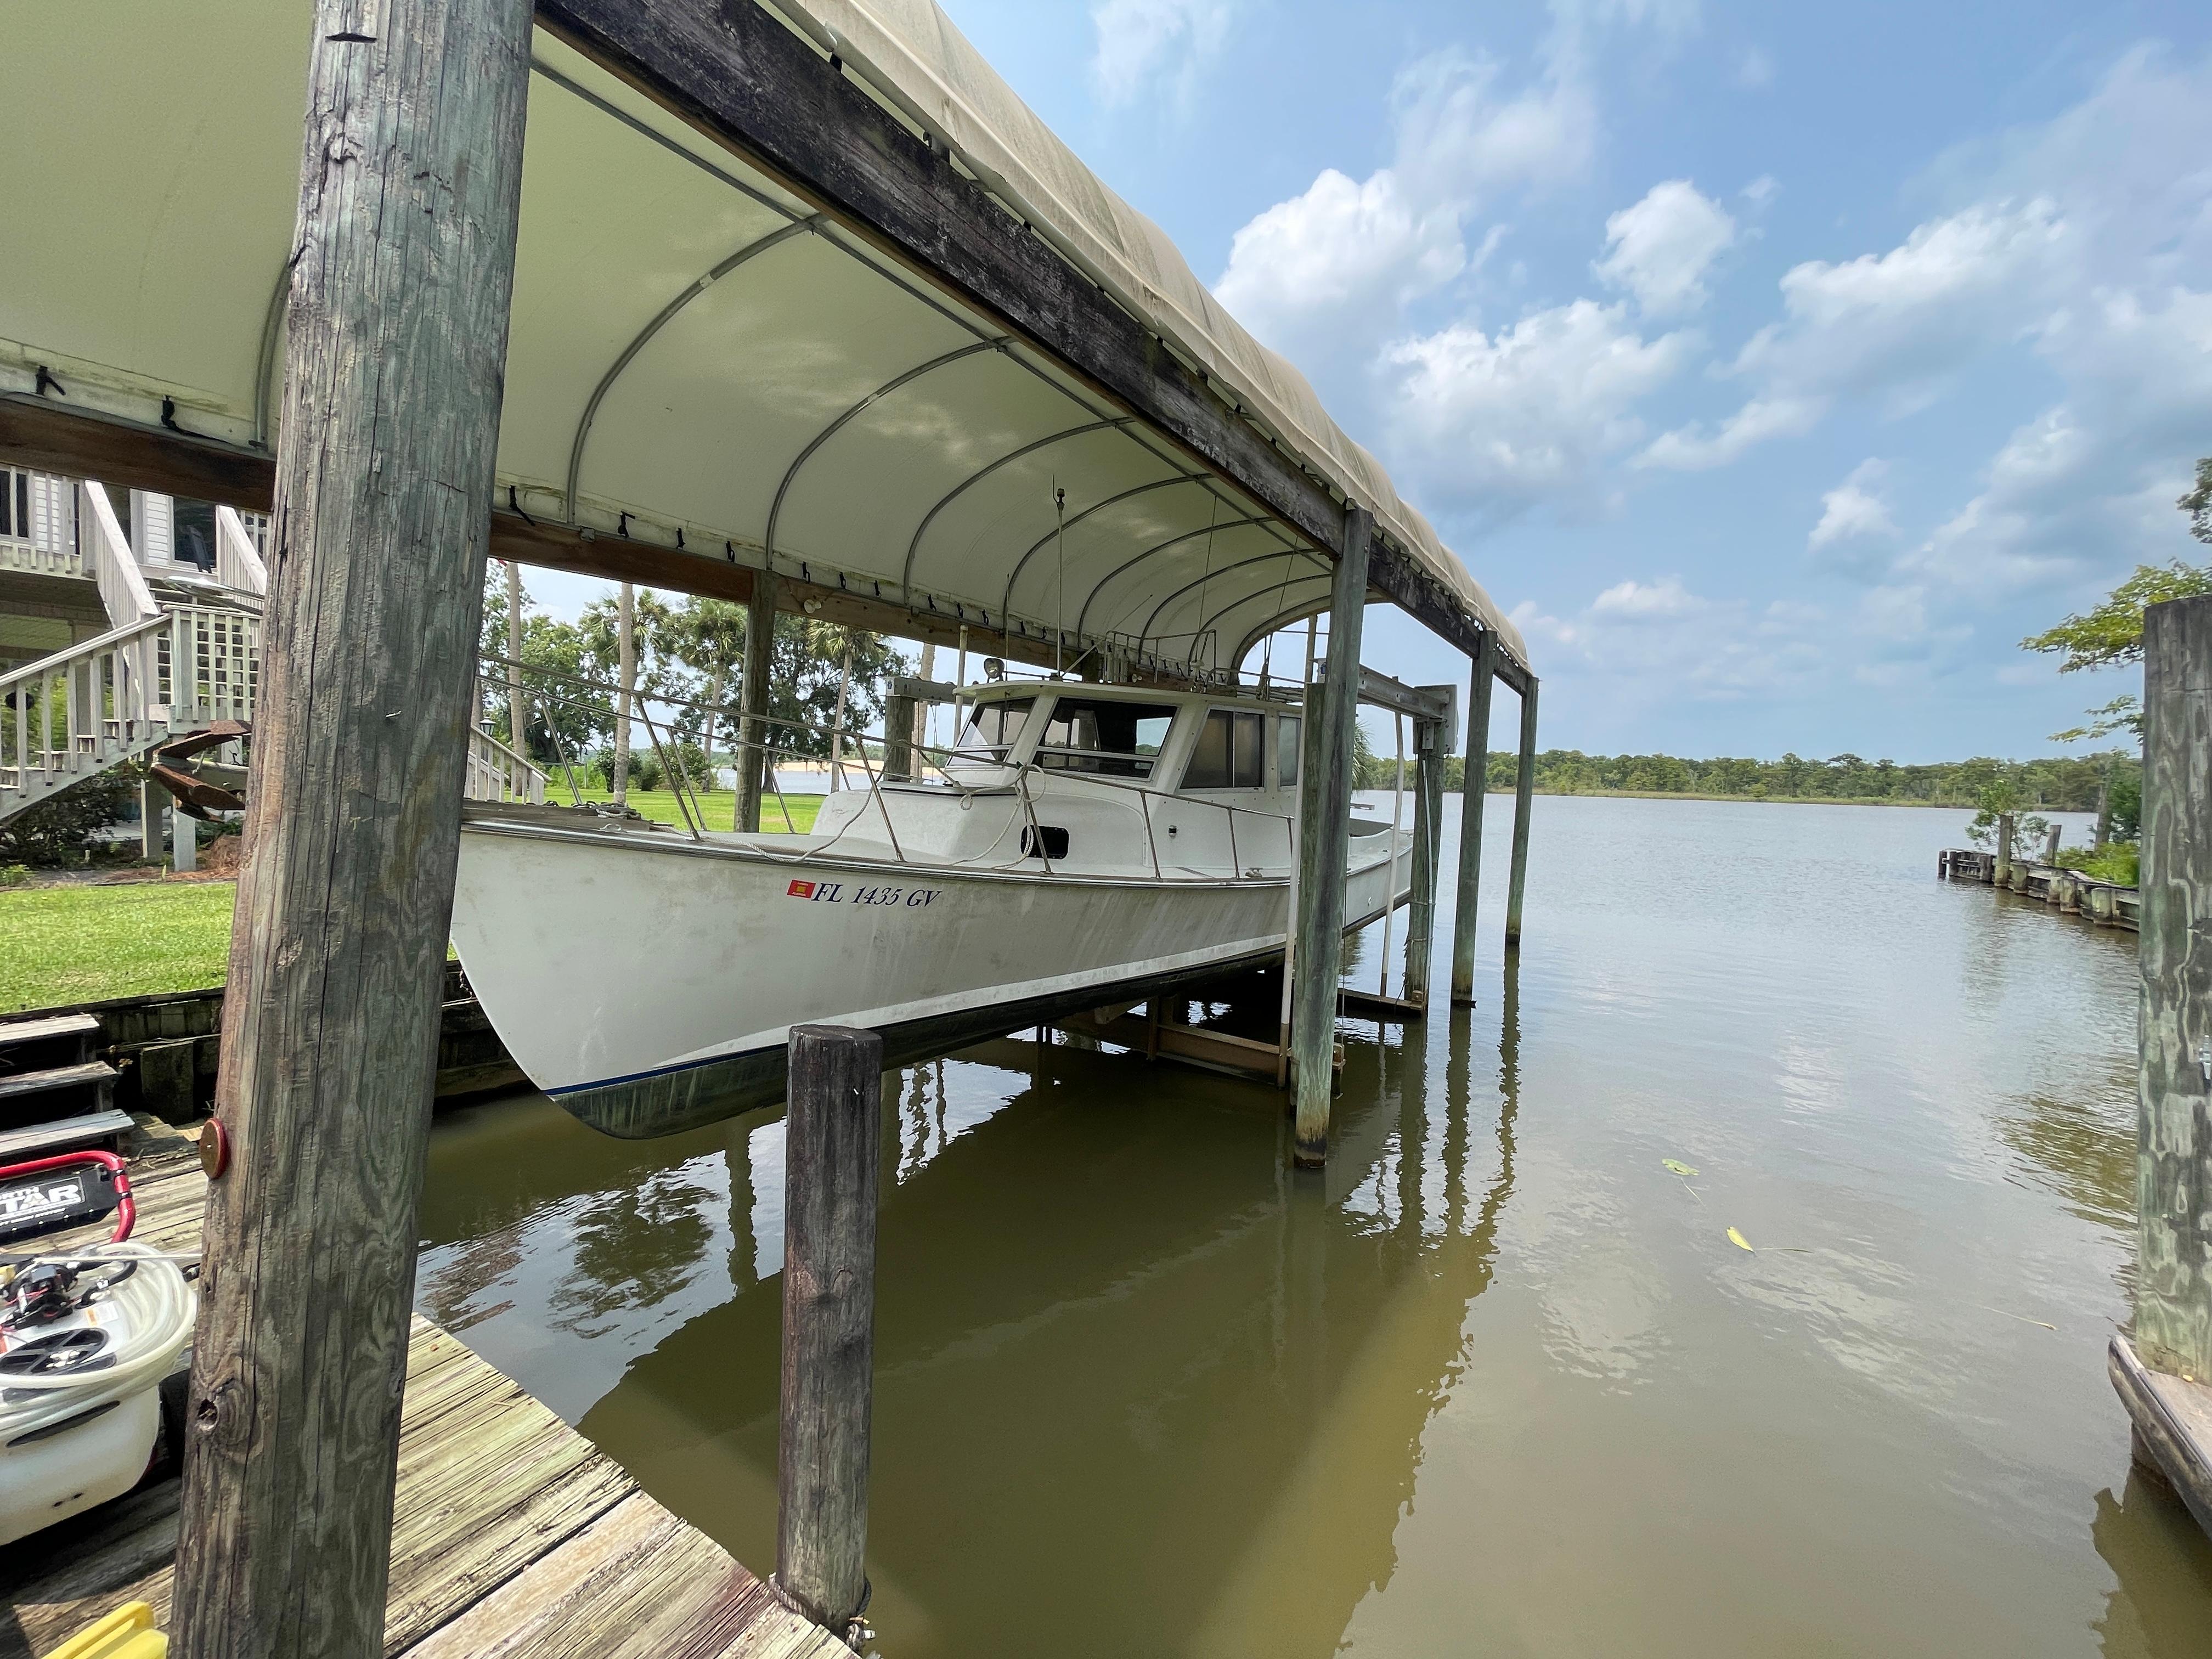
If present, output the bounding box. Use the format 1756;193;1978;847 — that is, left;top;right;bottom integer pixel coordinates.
170;0;531;1659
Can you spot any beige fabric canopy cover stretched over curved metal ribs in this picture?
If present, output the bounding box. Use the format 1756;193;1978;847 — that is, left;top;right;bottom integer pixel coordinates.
0;0;1526;673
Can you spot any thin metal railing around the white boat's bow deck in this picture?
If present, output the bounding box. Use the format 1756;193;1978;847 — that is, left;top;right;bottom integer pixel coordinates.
478;654;1296;885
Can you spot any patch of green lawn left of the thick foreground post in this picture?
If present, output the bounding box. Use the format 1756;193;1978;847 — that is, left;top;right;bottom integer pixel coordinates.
0;881;236;1013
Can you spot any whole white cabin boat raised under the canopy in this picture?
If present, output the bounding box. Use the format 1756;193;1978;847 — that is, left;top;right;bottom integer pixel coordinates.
454;681;1411;1137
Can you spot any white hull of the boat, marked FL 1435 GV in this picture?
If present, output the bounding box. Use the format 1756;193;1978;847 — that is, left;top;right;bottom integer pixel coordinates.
454;821;1404;1137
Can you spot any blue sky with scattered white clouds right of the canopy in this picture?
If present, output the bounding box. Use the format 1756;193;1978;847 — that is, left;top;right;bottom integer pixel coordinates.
533;0;2212;761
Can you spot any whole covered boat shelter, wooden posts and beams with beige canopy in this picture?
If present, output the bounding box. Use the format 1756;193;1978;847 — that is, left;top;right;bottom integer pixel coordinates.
0;0;1537;1659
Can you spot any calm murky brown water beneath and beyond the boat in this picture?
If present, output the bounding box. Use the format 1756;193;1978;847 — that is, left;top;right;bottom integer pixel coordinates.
402;799;2212;1659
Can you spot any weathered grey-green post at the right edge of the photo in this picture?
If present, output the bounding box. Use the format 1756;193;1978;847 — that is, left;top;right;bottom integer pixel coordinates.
2111;597;2212;1526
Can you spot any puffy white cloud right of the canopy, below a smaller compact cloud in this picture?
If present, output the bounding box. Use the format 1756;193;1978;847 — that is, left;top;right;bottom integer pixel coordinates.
1385;298;1697;520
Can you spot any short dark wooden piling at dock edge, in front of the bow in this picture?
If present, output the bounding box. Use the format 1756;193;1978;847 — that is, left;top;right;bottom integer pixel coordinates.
776;1026;883;1637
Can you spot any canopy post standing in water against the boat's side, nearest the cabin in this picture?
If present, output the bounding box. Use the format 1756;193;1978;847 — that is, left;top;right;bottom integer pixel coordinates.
1290;506;1374;1168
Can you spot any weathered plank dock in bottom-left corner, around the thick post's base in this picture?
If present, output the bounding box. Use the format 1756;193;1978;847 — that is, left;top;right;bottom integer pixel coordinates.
0;1126;849;1659
